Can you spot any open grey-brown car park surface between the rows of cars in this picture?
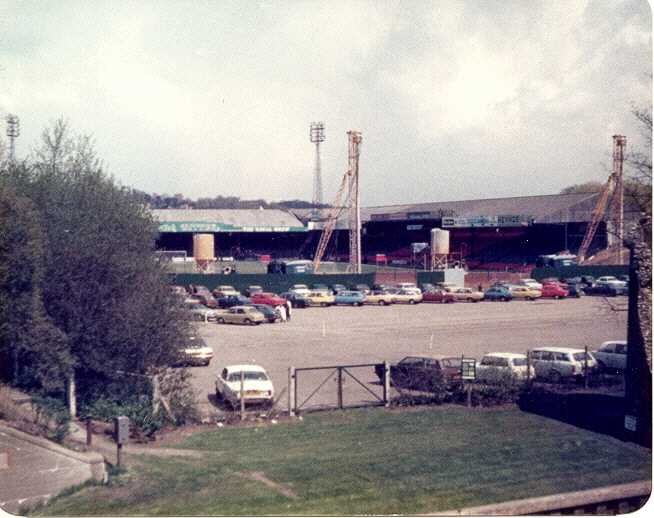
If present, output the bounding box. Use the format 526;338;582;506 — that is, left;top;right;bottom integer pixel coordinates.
191;297;627;413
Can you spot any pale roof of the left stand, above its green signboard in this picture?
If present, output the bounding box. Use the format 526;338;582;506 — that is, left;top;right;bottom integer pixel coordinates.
152;209;304;227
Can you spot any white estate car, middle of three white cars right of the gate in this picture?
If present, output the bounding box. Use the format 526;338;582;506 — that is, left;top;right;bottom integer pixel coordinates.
529;347;597;383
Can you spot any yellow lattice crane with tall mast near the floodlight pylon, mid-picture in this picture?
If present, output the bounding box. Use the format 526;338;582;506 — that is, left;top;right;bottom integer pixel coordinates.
313;131;361;273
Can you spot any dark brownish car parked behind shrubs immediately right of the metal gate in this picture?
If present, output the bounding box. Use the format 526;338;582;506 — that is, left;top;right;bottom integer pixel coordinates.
375;356;461;391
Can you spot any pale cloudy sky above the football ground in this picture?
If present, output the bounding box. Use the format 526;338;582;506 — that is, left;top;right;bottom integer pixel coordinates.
0;0;652;206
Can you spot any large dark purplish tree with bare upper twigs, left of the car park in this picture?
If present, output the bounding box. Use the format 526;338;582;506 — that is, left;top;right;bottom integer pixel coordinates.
6;120;188;420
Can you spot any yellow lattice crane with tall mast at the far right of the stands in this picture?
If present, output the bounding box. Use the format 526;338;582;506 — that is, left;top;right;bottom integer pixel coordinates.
577;135;627;264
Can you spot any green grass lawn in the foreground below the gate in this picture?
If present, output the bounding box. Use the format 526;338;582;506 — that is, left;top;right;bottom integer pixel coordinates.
33;407;651;515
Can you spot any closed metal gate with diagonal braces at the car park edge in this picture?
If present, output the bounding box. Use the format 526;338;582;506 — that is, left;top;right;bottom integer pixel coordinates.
288;362;390;415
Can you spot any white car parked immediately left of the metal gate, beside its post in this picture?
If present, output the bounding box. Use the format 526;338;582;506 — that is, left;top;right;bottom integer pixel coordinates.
216;364;275;408
